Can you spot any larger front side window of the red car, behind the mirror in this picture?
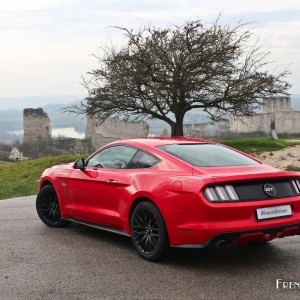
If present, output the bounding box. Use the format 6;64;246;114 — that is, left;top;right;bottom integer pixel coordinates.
86;146;138;169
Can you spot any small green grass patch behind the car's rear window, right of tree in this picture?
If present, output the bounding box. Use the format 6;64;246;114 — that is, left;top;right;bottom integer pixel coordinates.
221;137;295;154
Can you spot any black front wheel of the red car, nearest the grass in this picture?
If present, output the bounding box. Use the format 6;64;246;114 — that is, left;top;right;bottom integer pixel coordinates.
36;185;71;227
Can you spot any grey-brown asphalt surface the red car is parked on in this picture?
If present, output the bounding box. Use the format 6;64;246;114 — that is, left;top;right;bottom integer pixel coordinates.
0;197;300;300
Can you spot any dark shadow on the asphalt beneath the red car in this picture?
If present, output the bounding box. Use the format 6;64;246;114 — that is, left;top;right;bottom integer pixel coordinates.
69;224;293;269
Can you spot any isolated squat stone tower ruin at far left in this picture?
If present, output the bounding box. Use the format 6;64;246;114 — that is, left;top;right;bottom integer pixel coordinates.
23;108;51;143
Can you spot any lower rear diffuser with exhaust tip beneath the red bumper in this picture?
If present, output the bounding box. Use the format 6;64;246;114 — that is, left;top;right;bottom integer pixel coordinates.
174;223;300;248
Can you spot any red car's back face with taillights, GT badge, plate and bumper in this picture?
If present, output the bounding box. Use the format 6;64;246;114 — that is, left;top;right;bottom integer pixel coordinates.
172;167;300;247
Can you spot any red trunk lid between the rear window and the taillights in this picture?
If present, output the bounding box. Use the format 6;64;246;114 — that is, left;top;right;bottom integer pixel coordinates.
193;164;300;182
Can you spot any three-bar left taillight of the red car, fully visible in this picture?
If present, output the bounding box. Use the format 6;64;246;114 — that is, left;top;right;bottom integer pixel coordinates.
204;184;239;202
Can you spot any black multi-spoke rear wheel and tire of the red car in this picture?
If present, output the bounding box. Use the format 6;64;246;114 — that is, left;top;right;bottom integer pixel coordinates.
130;201;169;261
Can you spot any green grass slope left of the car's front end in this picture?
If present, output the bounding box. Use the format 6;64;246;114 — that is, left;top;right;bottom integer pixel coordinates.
0;155;79;200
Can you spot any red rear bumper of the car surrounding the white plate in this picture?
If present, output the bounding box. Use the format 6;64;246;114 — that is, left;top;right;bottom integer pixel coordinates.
164;196;300;248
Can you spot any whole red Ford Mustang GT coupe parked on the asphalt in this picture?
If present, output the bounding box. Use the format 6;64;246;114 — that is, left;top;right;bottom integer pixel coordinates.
36;138;300;261
